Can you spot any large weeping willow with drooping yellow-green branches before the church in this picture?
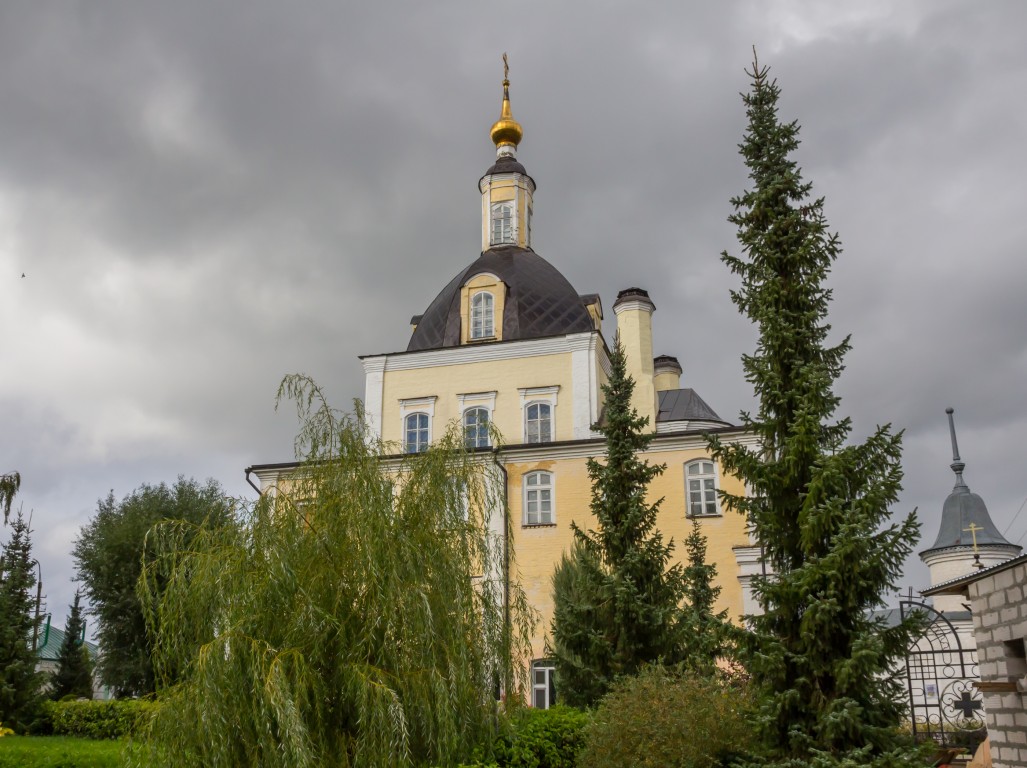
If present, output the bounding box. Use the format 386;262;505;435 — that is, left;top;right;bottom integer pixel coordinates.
132;376;531;768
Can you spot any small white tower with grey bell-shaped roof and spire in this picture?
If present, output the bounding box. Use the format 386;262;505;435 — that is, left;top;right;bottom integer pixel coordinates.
920;408;1023;611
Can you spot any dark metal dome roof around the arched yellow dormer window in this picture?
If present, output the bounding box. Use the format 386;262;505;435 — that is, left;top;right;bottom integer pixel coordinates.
407;245;595;352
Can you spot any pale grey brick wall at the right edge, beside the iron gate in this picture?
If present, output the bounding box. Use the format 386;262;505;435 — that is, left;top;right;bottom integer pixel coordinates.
968;563;1027;768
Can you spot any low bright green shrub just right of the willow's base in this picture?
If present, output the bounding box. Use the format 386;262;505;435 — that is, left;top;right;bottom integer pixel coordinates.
486;706;589;768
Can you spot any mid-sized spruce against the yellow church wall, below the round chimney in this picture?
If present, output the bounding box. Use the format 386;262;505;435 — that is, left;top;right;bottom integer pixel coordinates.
553;340;684;705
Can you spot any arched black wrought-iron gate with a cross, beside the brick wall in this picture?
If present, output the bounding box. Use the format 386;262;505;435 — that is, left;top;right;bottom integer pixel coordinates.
899;597;987;754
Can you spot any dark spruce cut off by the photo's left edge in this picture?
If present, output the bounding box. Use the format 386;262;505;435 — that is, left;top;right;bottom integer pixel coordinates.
0;511;41;731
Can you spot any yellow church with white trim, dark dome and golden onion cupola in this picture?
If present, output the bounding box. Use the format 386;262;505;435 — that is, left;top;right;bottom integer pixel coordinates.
251;71;760;706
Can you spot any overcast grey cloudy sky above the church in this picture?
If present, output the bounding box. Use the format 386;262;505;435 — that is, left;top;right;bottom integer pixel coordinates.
0;0;1027;624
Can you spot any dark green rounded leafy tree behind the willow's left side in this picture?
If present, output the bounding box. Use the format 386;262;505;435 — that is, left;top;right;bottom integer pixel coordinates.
72;477;234;696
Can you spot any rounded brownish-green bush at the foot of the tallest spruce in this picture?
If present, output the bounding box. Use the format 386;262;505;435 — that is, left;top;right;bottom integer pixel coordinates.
578;666;753;768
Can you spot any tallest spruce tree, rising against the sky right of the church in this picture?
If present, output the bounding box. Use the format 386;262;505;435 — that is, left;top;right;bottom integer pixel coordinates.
710;52;918;766
